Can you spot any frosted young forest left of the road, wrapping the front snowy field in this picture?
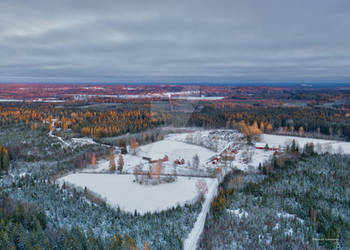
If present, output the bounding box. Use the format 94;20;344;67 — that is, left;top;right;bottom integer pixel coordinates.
0;127;201;249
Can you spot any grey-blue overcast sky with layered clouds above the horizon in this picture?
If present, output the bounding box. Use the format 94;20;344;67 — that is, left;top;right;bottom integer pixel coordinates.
0;0;350;83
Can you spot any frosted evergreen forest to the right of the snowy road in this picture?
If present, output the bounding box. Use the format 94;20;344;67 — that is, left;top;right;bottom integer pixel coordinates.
200;153;350;249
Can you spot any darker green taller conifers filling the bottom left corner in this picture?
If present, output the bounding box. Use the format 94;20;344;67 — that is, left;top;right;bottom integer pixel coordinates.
0;189;142;250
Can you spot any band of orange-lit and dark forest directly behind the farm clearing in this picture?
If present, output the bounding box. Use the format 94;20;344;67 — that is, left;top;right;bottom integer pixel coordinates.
0;102;350;140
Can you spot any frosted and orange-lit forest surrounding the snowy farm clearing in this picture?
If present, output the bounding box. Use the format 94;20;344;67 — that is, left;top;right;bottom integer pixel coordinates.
0;94;350;249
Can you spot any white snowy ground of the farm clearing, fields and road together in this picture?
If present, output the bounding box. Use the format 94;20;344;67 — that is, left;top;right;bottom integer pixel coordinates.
54;130;350;249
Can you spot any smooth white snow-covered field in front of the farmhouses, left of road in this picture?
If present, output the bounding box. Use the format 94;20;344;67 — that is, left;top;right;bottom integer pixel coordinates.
59;173;216;214
